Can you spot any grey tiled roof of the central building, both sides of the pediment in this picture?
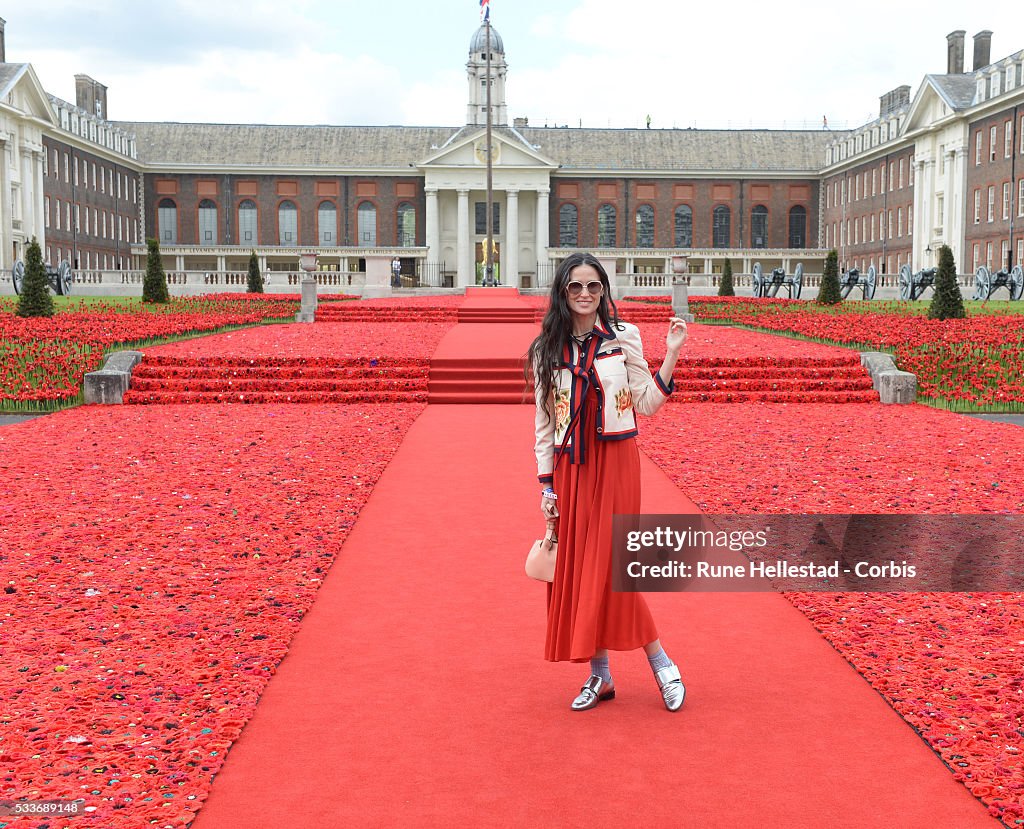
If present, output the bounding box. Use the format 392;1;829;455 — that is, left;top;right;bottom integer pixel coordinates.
119;121;836;175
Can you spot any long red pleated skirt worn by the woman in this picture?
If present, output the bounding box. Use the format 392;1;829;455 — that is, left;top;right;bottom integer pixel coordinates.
544;390;657;662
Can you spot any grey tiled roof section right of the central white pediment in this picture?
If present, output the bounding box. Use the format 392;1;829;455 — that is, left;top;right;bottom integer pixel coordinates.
519;127;836;170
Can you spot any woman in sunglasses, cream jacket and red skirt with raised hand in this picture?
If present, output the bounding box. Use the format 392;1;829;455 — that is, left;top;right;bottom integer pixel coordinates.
528;254;686;711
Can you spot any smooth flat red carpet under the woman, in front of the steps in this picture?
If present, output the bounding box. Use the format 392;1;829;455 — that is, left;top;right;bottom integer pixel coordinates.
194;405;997;829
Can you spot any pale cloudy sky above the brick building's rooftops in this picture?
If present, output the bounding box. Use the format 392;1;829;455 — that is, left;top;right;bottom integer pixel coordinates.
0;0;1024;129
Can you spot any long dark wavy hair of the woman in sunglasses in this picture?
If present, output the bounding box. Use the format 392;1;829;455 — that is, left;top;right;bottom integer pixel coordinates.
524;253;618;419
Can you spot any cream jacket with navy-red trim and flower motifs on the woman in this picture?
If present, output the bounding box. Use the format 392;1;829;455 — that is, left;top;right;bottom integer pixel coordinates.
534;320;675;483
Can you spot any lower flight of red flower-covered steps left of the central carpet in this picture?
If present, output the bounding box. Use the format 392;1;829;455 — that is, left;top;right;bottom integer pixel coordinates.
124;356;429;403
